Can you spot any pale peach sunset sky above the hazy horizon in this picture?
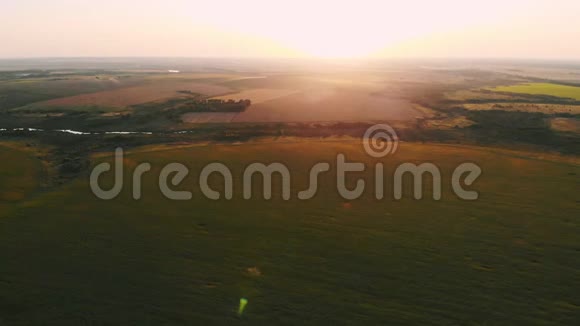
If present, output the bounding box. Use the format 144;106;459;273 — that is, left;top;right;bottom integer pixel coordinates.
0;0;580;60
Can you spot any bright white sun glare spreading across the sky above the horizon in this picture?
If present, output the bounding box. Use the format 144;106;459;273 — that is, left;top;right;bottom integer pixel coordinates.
194;0;524;58
